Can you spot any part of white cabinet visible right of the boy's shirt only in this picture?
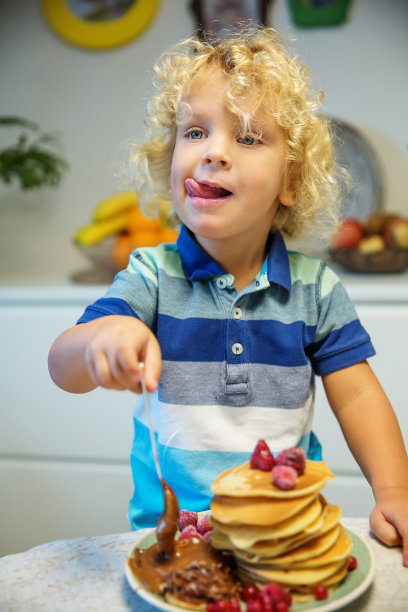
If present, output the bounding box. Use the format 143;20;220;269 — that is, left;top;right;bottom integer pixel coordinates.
315;276;408;517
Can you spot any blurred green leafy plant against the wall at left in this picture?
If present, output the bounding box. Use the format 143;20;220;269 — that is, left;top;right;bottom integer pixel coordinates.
0;117;68;190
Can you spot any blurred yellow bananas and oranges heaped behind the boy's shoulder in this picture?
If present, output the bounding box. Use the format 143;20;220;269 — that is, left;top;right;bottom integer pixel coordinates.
73;191;178;269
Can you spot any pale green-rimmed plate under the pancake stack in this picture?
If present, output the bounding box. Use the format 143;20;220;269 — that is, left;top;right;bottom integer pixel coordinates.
125;528;374;612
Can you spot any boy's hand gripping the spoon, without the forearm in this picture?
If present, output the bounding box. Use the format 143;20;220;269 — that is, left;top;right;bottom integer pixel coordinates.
84;315;161;393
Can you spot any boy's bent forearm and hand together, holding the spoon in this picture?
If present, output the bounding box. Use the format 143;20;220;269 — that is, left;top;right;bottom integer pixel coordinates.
48;315;161;393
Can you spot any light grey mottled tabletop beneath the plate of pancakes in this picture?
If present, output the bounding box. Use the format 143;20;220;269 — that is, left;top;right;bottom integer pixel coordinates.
0;518;408;612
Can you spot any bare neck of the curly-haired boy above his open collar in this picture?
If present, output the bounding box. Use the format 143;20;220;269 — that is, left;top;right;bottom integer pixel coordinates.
196;234;269;292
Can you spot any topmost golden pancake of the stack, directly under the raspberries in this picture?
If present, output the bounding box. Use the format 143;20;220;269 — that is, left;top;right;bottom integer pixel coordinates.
211;460;334;500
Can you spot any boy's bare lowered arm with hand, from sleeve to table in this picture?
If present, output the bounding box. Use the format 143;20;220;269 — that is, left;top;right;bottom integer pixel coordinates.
322;362;408;567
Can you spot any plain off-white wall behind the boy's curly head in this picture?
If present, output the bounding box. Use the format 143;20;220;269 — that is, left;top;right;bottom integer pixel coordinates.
0;0;408;285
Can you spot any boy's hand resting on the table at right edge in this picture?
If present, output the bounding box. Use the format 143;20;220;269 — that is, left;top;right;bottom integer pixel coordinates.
370;487;408;567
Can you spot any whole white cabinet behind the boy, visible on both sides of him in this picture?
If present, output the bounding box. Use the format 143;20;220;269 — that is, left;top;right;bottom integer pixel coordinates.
0;275;408;555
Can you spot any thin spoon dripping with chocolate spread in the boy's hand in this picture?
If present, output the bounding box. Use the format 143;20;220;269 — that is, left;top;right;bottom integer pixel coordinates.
141;368;179;559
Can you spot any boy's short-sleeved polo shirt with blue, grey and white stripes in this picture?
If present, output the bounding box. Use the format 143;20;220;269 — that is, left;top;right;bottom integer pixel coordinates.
78;226;374;529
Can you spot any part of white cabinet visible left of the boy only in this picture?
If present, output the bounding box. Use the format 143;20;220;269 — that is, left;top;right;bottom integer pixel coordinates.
0;288;134;555
